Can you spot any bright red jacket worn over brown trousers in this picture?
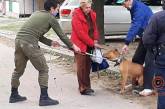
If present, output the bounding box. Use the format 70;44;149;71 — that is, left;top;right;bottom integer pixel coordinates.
71;8;99;52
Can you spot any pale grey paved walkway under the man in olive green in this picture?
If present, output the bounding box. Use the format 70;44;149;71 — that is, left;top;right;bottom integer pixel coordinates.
0;44;146;109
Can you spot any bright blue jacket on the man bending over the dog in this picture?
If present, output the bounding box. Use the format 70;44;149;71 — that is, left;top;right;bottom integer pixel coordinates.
125;0;153;45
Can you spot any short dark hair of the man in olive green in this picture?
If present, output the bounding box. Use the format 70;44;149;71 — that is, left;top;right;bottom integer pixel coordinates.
44;0;59;11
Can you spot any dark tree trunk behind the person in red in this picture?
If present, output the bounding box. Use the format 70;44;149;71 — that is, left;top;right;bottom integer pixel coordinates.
92;0;105;44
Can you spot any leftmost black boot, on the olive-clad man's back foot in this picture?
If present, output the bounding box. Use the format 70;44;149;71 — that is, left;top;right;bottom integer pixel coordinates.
9;88;27;103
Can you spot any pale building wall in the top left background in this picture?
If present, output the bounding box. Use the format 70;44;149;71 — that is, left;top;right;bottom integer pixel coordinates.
0;0;44;17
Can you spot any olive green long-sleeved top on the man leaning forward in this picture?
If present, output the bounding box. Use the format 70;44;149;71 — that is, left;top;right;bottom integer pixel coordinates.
16;10;72;48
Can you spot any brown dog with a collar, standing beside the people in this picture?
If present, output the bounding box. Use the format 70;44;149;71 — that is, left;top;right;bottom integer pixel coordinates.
104;49;143;93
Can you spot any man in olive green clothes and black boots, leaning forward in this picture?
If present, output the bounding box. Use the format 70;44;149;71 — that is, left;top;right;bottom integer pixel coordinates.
9;0;79;106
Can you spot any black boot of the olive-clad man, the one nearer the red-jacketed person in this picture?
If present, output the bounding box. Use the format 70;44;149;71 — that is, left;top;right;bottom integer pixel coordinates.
39;87;59;106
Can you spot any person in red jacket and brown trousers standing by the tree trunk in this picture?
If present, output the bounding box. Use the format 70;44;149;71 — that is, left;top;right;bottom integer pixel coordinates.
71;0;101;95
